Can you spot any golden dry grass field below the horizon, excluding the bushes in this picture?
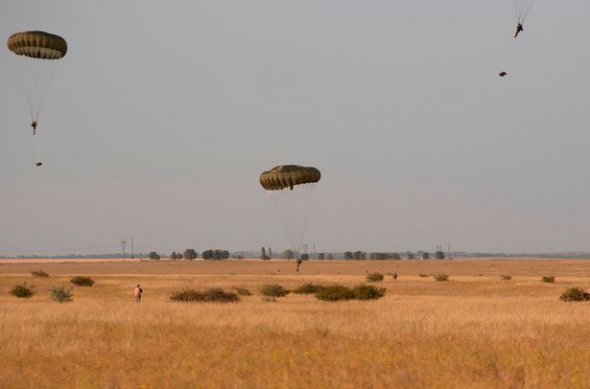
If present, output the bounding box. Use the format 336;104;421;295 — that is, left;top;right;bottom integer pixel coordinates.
0;260;590;388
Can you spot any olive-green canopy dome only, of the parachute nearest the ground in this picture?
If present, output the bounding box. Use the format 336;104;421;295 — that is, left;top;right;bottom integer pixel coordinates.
260;165;322;190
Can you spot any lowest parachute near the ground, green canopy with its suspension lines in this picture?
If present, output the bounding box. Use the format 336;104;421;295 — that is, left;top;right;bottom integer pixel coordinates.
260;165;321;258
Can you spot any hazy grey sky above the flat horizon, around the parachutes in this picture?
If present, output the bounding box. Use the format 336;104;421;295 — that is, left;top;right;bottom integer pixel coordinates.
0;0;590;255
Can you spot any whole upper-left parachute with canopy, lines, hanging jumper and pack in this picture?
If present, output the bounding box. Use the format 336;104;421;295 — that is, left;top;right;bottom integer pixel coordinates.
7;31;68;166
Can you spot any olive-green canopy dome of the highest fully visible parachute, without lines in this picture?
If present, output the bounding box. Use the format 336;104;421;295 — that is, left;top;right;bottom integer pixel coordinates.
7;31;68;59
